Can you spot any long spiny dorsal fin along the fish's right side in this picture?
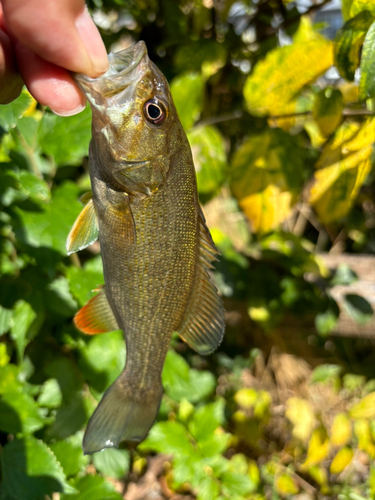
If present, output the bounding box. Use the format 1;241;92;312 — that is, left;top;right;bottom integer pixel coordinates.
177;210;225;354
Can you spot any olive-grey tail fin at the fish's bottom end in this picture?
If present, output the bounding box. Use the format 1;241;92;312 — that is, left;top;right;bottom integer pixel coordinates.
83;371;163;454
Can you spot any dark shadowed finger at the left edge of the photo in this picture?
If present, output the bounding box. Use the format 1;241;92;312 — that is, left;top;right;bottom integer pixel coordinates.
0;30;23;104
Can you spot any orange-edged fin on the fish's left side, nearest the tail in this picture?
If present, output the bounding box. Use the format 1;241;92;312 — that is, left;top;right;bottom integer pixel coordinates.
74;287;119;335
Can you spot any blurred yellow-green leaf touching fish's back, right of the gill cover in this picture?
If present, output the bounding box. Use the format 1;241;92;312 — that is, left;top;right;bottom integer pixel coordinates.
188;126;227;202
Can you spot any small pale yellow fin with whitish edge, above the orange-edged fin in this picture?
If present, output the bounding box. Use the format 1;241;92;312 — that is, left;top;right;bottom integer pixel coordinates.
66;193;99;255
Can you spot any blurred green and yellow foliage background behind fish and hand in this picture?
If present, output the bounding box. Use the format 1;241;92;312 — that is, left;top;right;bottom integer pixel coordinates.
0;0;375;500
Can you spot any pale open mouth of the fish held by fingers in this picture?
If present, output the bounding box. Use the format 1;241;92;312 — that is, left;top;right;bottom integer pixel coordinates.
73;41;149;108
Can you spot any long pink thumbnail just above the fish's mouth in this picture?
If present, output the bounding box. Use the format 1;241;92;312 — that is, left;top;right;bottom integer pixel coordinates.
76;7;108;77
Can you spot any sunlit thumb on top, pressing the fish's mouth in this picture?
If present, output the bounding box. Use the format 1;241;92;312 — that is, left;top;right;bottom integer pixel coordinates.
2;0;108;77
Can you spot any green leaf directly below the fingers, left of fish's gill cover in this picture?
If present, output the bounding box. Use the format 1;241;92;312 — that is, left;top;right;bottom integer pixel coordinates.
39;106;91;165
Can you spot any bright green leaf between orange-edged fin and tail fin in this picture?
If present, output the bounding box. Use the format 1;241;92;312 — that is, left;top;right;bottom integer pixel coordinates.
79;330;126;392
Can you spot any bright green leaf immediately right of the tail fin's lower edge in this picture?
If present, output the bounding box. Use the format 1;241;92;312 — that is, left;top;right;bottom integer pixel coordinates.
138;421;194;455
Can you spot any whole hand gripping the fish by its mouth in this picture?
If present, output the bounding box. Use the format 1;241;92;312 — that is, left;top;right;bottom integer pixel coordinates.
0;0;108;116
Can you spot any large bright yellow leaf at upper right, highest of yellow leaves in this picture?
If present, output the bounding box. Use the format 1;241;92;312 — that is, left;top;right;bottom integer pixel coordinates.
244;17;333;116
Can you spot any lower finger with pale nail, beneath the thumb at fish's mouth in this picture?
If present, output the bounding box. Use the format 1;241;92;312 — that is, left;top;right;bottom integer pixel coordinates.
15;42;86;116
